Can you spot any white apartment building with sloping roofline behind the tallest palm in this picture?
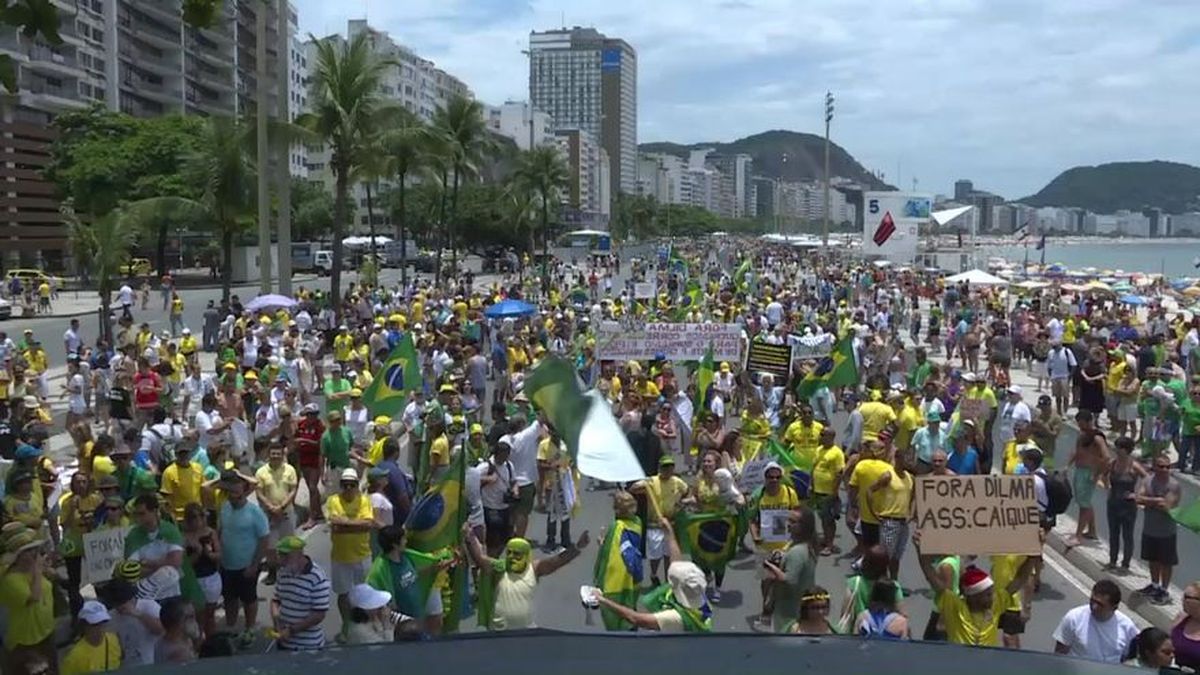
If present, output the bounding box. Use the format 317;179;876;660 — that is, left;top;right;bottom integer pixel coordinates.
305;19;474;235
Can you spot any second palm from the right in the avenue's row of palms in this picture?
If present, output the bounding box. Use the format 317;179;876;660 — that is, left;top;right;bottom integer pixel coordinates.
433;95;494;278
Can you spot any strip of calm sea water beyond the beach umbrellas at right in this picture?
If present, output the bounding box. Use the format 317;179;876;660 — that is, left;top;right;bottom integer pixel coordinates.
979;239;1200;279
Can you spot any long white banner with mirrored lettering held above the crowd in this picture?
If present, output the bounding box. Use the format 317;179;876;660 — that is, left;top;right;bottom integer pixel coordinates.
595;321;742;363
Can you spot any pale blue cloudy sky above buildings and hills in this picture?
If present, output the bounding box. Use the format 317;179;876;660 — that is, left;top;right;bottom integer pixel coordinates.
293;0;1200;198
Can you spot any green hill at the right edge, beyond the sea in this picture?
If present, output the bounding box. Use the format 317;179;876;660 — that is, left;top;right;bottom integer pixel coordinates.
1020;161;1200;214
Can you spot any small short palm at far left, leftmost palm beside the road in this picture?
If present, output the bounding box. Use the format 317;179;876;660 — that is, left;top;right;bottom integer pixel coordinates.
67;207;138;345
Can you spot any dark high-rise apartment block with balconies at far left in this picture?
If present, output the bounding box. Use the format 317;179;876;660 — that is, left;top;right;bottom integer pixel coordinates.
0;0;302;269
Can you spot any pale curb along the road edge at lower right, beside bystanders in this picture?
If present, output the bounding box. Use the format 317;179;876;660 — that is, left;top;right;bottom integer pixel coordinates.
1046;514;1183;632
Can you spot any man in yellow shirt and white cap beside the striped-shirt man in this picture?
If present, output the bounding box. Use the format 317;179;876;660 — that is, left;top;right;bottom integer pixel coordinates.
325;467;374;635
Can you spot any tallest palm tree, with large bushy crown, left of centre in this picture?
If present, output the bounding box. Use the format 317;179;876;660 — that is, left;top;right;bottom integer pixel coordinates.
296;34;389;317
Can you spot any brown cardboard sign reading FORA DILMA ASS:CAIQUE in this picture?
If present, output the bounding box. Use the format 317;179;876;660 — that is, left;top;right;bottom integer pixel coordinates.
916;476;1042;555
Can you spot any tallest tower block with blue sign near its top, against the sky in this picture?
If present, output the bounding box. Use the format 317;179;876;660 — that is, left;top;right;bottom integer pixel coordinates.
529;26;637;210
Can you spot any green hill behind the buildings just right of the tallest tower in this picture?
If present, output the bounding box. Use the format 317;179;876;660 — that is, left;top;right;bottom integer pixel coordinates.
638;130;895;190
